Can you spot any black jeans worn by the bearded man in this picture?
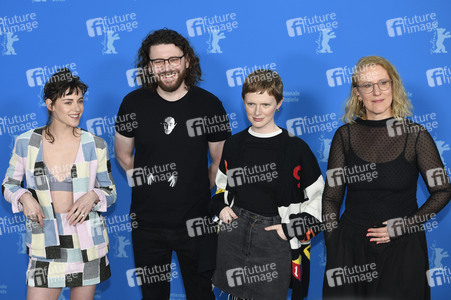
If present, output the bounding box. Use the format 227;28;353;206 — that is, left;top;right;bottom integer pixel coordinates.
132;227;215;300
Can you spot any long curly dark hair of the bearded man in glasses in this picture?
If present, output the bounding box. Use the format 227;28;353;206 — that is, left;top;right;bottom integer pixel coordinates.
135;28;202;90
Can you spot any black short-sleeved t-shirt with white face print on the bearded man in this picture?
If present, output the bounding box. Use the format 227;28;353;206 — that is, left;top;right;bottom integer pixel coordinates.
116;87;231;228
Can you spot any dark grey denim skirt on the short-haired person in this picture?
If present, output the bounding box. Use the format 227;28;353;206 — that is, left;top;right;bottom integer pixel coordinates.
213;206;291;300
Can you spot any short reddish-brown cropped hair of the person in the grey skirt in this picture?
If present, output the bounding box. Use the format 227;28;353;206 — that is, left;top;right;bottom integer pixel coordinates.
241;69;283;104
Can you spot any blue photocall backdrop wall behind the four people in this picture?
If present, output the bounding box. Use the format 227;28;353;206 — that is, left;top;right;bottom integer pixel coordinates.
0;0;451;300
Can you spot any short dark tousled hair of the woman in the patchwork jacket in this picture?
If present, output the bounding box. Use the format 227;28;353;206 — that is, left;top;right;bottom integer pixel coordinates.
42;68;88;143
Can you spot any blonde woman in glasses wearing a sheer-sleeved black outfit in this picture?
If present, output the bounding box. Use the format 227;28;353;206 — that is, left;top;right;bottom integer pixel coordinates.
322;56;451;299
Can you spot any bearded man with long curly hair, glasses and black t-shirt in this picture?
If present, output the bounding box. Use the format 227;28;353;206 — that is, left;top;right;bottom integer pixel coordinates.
115;28;231;300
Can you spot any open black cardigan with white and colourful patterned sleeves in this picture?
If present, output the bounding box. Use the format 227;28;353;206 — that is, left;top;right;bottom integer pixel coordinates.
209;129;324;299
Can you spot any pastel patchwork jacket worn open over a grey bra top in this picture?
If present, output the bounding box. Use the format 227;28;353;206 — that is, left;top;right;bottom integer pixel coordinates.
2;127;116;262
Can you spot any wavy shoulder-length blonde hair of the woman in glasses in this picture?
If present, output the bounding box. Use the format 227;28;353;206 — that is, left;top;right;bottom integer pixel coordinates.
342;56;413;123
